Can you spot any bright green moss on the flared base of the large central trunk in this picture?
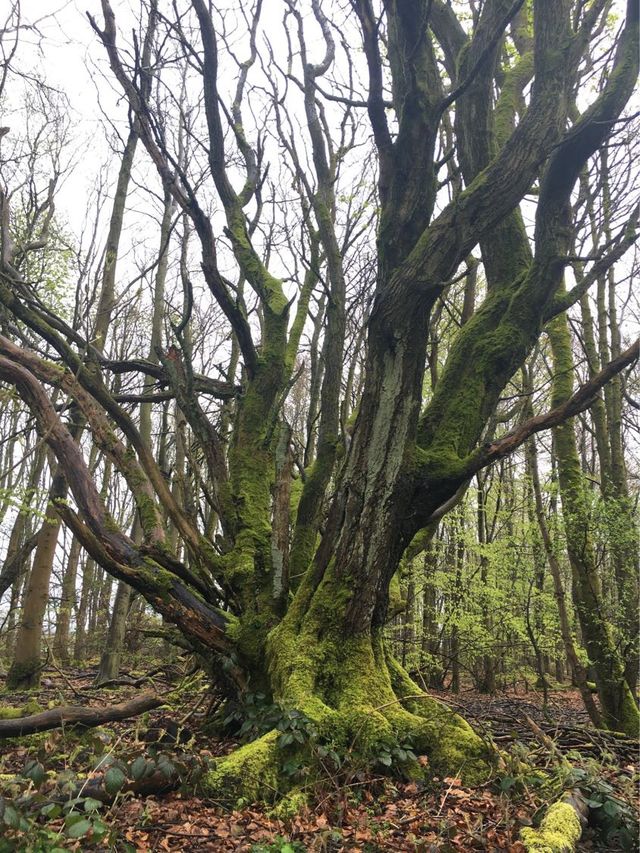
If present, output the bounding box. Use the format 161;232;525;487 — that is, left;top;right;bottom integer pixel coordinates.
268;587;493;782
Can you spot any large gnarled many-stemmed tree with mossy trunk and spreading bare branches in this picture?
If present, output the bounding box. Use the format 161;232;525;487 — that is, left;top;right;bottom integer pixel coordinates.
0;0;638;798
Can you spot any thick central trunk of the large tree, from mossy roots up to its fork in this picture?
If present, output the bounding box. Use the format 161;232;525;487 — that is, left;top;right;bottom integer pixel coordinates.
200;306;490;796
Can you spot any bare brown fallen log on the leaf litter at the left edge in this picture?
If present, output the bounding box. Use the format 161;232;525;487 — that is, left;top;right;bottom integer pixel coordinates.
0;691;165;738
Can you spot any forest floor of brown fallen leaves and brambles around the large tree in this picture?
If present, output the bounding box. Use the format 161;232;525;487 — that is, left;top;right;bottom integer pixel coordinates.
0;668;639;853
